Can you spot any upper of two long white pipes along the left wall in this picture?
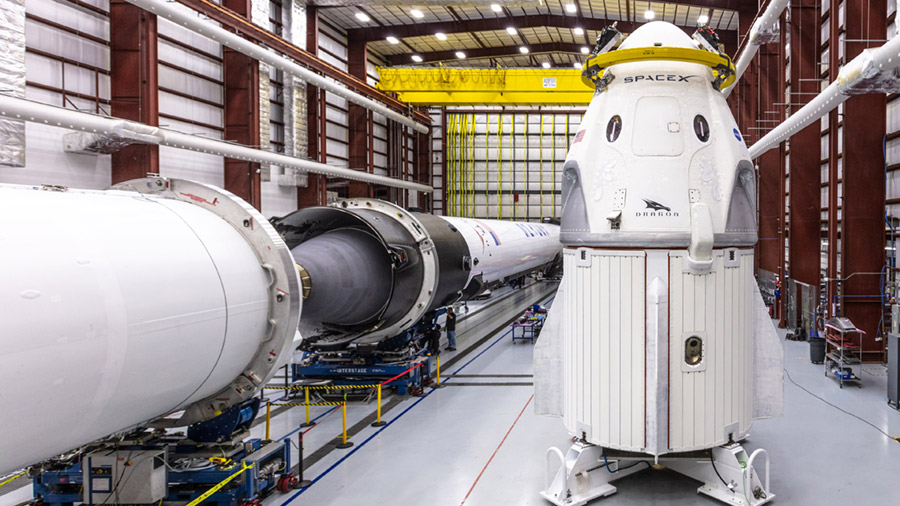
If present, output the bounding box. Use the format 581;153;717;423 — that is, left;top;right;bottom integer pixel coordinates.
125;0;428;134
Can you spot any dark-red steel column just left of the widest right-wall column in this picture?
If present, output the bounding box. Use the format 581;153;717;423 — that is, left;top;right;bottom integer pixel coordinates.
788;0;822;287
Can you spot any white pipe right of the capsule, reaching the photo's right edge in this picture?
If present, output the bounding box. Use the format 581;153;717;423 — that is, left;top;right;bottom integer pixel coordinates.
750;35;900;158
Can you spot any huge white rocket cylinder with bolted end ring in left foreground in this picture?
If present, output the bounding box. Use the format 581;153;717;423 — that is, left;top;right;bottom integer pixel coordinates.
0;178;301;475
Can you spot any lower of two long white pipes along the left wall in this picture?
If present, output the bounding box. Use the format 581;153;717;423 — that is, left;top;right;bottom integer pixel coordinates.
0;94;433;193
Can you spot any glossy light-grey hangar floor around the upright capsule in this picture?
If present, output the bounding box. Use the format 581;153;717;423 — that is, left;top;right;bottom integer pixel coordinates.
7;287;900;506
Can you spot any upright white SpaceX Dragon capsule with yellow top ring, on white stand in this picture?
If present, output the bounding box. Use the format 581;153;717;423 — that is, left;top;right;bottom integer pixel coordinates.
535;22;783;505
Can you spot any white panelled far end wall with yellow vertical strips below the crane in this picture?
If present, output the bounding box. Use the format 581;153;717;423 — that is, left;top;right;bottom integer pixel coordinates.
432;108;583;221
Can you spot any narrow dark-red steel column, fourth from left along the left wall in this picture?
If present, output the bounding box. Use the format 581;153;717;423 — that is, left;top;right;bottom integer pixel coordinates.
347;38;373;198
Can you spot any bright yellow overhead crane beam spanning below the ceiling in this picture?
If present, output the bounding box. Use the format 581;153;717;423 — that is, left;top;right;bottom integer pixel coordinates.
376;67;594;106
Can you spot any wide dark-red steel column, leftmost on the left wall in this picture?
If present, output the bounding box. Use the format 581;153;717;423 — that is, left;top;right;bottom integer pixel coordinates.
109;0;159;184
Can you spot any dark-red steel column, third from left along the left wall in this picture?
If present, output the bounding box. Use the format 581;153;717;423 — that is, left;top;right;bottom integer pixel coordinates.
297;5;328;209
